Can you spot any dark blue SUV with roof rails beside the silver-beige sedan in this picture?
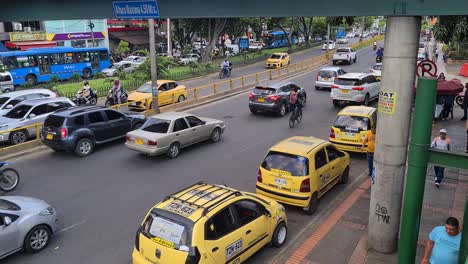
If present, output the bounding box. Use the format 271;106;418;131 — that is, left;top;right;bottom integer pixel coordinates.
41;106;146;157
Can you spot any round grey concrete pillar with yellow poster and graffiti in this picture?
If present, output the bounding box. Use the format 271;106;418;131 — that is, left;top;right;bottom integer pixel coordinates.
368;17;421;253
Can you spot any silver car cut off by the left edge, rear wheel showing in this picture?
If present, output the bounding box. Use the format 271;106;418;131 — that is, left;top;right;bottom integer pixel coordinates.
0;196;58;259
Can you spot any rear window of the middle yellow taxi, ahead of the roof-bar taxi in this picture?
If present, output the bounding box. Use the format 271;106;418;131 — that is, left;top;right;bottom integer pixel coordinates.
262;151;309;176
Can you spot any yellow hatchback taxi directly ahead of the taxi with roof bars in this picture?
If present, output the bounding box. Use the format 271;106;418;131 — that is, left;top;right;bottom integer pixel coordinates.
256;137;349;214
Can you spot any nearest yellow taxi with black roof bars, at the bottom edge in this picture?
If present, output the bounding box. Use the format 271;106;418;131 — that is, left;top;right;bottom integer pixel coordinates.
132;182;287;264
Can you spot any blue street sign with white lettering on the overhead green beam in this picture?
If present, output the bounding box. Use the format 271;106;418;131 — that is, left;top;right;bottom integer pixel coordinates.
112;0;159;18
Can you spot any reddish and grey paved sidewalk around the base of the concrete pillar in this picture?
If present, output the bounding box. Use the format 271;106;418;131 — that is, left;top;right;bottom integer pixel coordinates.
274;107;468;264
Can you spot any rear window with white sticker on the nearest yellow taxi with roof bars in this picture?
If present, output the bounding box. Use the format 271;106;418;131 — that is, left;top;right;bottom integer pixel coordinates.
143;213;187;249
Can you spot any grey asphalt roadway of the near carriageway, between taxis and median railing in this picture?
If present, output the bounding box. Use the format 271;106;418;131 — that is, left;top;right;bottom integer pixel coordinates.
2;41;374;264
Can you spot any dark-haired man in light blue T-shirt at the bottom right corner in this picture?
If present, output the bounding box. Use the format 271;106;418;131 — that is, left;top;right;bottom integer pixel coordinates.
421;217;461;264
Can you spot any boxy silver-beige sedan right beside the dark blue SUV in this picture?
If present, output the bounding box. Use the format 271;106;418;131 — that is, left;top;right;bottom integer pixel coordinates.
125;112;226;159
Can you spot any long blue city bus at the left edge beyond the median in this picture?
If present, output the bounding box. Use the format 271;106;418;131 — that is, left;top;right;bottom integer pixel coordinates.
0;47;110;85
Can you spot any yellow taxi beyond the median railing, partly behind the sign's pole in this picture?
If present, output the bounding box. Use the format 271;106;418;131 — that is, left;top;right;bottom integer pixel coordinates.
128;80;187;111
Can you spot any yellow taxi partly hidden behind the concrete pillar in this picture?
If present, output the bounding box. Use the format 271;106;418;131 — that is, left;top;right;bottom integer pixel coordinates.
329;106;377;153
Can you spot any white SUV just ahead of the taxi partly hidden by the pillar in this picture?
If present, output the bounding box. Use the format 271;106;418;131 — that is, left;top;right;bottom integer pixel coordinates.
331;73;380;106
